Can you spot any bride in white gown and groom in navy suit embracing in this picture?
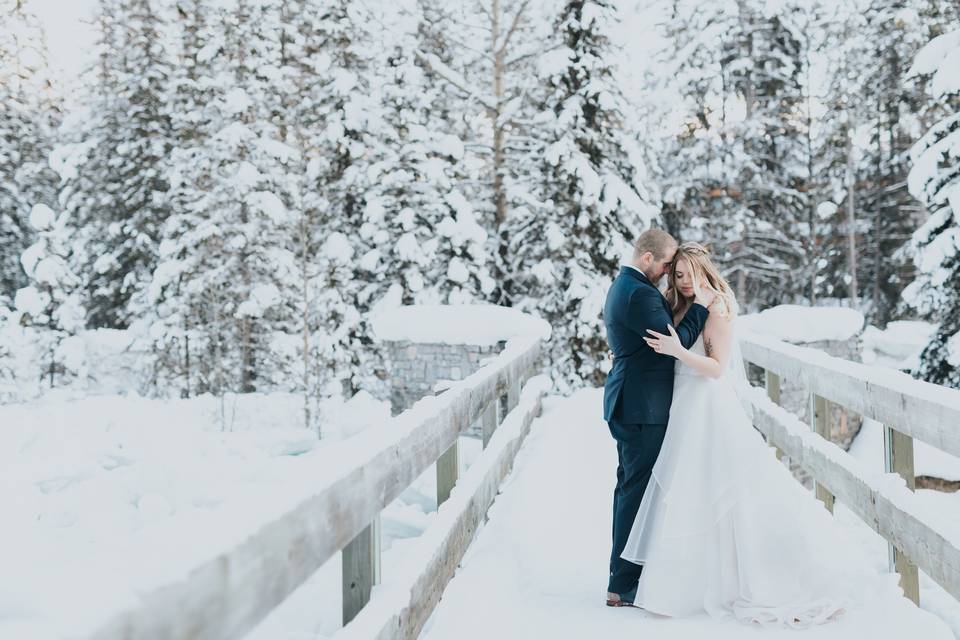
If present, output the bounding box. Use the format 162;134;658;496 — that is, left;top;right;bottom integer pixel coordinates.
603;229;863;627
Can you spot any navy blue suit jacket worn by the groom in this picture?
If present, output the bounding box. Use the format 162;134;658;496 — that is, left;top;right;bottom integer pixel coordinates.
603;267;710;424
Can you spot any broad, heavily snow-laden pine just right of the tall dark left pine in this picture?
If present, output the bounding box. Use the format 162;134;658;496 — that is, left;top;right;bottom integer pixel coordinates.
146;0;296;394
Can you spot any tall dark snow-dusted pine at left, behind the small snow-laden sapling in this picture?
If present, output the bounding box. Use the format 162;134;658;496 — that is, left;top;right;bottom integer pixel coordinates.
62;0;173;327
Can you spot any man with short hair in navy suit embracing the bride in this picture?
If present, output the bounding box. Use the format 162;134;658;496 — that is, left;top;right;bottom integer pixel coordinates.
603;229;709;607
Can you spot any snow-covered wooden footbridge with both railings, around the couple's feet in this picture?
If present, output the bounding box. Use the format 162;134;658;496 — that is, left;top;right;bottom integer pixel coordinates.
83;336;960;640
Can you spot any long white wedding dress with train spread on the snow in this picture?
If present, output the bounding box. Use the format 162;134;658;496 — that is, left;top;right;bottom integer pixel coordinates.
621;336;877;627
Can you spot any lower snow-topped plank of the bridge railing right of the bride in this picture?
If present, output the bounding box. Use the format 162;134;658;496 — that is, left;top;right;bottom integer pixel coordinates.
749;394;960;599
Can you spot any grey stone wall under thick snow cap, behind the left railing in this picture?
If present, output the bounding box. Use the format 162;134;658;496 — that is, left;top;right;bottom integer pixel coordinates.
375;341;504;415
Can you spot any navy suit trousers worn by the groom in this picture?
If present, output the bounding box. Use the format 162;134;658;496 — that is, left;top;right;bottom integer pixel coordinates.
607;418;667;594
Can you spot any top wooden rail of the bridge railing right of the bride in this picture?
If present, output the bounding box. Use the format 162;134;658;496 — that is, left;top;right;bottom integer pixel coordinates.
741;333;960;456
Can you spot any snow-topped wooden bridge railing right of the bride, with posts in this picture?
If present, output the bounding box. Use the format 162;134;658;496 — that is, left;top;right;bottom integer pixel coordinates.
742;334;960;604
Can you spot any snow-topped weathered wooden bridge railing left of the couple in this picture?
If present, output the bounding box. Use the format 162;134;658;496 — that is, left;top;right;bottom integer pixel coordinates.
84;338;549;640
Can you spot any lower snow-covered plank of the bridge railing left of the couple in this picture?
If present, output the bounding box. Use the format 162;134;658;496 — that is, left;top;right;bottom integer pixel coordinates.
334;379;549;640
